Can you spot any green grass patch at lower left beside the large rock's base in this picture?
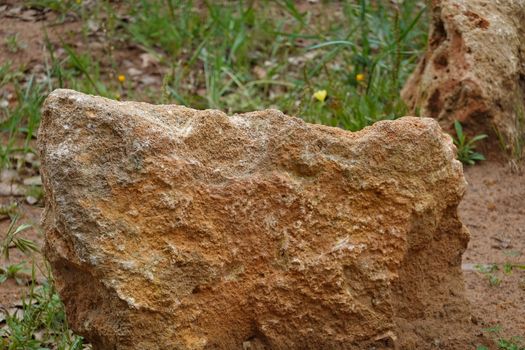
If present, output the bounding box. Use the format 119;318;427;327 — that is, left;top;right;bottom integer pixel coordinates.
0;213;84;350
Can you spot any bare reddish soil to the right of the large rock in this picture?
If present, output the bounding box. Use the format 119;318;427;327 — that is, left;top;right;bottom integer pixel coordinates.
459;162;525;344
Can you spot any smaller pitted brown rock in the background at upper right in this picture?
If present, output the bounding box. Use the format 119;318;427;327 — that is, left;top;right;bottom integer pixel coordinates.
401;0;525;146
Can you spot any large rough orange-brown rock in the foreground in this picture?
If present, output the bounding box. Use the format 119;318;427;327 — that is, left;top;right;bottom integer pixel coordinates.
39;90;468;349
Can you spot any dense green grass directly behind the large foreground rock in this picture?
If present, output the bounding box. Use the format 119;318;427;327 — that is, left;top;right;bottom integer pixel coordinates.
126;1;426;126
